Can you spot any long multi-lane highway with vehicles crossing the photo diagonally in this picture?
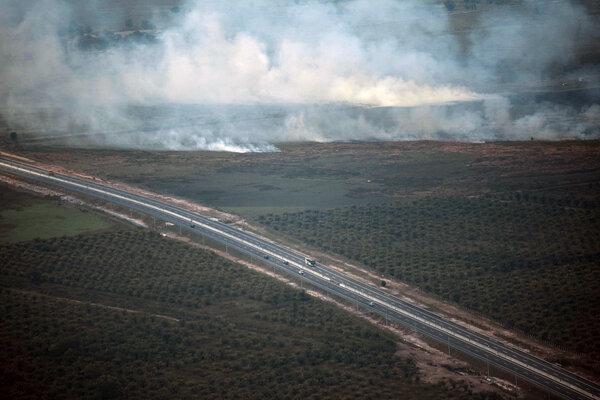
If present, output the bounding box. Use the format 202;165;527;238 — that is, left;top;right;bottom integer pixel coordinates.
0;158;600;400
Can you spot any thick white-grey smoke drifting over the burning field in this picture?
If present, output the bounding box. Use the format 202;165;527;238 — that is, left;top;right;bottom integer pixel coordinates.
0;0;600;151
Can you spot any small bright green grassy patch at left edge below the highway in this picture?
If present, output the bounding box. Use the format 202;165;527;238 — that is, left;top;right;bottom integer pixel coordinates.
0;185;115;242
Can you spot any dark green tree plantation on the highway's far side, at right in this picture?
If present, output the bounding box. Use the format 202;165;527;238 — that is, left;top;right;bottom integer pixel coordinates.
259;192;600;357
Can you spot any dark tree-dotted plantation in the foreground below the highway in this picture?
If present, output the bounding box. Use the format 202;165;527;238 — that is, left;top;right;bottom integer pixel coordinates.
0;209;506;399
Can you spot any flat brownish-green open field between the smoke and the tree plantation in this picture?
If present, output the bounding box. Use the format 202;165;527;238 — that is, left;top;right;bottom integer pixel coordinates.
5;141;600;217
